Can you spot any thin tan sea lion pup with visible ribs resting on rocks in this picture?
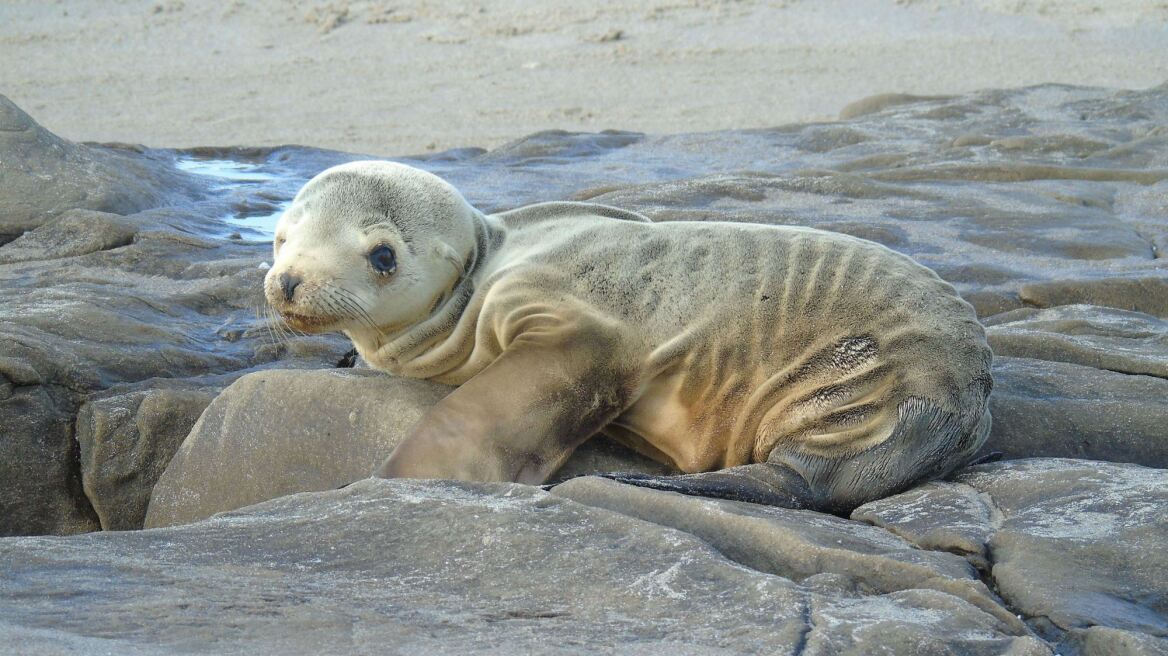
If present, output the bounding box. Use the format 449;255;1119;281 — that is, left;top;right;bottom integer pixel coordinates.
264;161;992;512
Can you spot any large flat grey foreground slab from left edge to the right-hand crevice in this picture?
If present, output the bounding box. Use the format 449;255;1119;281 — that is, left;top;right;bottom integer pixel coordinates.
0;480;1051;655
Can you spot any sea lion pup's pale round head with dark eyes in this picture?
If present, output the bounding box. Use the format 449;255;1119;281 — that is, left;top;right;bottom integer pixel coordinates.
264;161;478;339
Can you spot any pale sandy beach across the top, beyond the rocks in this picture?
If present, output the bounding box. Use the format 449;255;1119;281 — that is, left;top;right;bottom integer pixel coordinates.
0;0;1168;155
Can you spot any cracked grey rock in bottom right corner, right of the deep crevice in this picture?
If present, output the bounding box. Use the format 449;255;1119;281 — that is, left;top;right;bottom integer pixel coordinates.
958;460;1168;636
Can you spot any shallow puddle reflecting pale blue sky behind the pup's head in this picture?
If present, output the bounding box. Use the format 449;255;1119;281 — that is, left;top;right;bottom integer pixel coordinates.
174;156;304;240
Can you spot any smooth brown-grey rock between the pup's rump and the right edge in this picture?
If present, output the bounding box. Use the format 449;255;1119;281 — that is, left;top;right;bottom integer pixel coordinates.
982;357;1168;468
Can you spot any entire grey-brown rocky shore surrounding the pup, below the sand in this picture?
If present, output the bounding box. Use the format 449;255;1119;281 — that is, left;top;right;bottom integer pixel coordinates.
0;85;1168;654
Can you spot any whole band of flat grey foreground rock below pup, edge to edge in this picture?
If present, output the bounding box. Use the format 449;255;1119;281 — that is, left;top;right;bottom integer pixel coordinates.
0;459;1168;655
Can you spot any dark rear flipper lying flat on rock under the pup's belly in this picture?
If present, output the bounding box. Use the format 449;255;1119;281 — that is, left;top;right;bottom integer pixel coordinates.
598;462;819;509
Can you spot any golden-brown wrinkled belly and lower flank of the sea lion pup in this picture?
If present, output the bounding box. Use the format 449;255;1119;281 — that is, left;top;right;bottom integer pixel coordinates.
605;335;906;473
